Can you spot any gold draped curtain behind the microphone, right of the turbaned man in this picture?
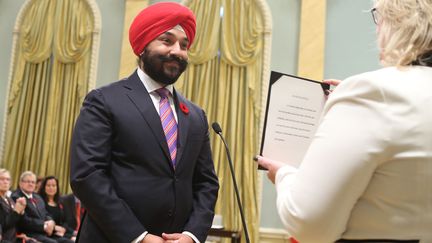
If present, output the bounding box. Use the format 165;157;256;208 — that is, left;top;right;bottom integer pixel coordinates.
176;0;267;242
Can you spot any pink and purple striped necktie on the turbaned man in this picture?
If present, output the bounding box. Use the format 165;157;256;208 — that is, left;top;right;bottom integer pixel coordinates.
156;88;177;168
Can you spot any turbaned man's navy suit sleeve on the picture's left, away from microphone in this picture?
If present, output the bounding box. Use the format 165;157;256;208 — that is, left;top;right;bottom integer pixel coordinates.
71;90;146;243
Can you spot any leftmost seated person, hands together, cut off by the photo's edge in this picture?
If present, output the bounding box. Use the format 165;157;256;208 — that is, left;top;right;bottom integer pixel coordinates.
0;169;26;243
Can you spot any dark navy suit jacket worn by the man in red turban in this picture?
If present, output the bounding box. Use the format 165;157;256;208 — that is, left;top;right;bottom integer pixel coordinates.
71;72;219;243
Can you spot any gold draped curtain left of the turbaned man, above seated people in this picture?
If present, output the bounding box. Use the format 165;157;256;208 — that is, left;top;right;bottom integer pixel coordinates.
2;0;96;193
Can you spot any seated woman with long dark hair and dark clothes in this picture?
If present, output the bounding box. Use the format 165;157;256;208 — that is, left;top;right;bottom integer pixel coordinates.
39;176;75;241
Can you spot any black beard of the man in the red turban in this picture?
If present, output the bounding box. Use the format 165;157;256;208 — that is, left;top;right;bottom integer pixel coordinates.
140;49;188;85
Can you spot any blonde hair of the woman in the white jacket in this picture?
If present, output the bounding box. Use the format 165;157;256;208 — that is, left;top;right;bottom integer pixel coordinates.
375;0;432;66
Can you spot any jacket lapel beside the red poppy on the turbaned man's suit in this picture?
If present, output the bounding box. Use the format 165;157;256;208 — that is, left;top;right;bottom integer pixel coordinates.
174;90;190;167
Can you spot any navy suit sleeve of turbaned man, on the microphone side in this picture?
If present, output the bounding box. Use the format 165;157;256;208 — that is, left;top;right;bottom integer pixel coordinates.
181;110;219;242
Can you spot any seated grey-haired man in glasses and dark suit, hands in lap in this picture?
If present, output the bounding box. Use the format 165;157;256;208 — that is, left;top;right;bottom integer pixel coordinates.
12;171;71;243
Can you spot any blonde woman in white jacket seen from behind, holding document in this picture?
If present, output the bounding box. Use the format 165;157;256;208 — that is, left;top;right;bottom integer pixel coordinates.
258;0;432;243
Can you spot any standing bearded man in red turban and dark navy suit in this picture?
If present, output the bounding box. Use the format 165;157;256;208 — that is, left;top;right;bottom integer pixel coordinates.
71;2;219;243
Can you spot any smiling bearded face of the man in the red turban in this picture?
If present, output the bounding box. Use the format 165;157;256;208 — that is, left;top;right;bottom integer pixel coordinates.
140;28;189;85
